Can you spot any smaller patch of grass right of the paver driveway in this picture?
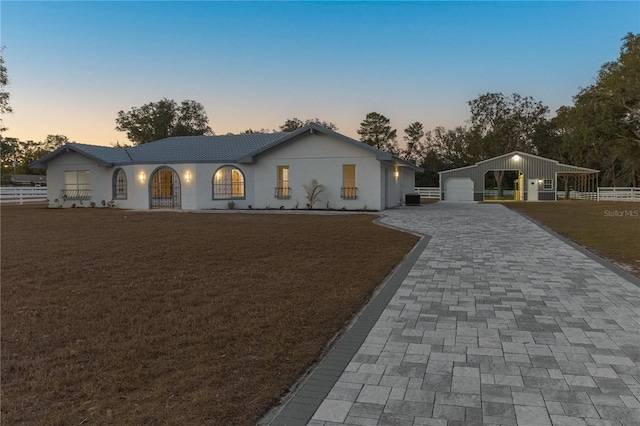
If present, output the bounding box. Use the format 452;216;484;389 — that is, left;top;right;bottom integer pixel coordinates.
504;200;640;278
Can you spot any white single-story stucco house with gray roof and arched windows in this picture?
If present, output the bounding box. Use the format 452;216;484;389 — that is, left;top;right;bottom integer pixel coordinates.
31;124;422;210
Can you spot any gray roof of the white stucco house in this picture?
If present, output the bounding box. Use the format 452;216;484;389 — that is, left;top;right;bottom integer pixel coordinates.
30;123;422;172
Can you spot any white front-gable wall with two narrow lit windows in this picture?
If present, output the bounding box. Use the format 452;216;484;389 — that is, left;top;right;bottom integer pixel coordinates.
253;134;381;210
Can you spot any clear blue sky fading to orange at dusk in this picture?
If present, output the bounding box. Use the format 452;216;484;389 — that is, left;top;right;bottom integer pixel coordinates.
0;0;640;145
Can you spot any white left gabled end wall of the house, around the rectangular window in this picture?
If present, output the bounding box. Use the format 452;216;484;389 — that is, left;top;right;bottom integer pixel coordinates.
47;152;113;207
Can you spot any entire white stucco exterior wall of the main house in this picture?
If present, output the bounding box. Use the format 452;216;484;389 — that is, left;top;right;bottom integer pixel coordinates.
42;134;415;210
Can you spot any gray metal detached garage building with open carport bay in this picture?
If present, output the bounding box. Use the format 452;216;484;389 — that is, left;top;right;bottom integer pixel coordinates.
439;151;599;201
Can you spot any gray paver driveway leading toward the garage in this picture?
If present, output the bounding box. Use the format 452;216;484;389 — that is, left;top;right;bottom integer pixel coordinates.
264;203;640;426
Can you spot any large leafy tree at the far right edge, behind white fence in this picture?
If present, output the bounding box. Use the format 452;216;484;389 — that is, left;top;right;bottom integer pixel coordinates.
545;33;640;186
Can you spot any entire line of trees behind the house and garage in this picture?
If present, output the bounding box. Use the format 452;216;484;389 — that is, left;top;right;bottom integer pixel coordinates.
0;33;640;187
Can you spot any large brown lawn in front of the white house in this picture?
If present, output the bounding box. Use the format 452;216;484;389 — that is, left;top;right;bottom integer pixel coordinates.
0;206;418;425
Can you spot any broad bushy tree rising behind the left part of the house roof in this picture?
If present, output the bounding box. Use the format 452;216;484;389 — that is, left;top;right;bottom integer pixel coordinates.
116;98;213;145
